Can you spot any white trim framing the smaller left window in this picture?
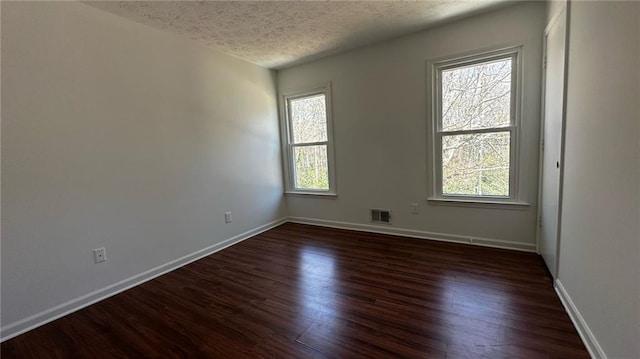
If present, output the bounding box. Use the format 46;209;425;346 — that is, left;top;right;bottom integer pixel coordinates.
280;82;337;197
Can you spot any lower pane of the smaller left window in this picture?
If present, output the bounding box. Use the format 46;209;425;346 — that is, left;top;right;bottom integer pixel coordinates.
293;145;329;190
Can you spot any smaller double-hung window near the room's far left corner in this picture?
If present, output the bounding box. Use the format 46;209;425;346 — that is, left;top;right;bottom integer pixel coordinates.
282;85;336;195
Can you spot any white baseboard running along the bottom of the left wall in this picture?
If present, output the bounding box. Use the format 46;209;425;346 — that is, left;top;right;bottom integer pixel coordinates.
0;218;287;342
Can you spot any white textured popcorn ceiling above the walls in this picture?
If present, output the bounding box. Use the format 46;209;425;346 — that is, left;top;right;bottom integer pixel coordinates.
87;0;506;69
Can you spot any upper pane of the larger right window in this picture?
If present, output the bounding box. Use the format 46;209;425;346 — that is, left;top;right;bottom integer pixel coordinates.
442;58;512;131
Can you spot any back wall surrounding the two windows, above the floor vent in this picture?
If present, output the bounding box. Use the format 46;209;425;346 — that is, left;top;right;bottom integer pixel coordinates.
278;2;545;249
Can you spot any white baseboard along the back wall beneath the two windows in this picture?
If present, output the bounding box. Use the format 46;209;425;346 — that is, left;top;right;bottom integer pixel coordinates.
288;217;536;253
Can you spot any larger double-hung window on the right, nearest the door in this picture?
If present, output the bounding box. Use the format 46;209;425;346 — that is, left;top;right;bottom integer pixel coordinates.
429;47;521;202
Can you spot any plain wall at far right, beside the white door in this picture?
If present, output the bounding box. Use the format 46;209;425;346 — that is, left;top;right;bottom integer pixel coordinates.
558;1;640;358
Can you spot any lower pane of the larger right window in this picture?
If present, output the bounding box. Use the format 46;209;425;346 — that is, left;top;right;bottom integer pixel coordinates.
442;132;511;197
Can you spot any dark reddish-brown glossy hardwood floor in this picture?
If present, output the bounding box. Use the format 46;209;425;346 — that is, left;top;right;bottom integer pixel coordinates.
0;223;589;359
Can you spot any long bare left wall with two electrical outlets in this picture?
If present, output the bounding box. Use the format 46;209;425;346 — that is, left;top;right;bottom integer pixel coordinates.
2;1;285;336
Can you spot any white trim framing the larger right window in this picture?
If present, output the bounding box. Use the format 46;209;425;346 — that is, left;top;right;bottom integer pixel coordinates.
426;45;529;208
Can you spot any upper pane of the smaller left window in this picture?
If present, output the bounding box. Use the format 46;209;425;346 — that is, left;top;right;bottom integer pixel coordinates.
289;94;327;143
